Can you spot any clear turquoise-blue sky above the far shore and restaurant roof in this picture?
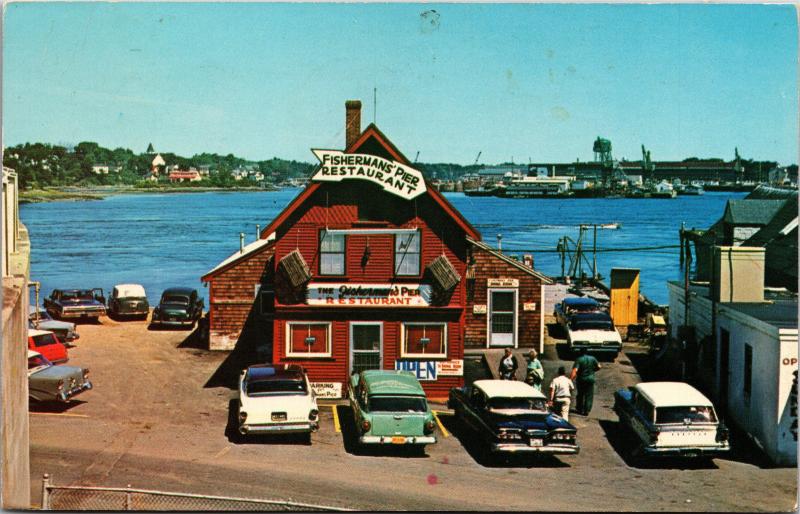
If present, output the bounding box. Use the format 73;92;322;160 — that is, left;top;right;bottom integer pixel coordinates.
2;2;800;164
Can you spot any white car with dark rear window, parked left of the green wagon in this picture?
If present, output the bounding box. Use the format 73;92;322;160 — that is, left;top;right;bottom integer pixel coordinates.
238;364;319;435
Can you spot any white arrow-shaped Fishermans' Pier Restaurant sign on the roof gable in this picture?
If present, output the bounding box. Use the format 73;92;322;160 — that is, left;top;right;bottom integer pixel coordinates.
311;150;425;200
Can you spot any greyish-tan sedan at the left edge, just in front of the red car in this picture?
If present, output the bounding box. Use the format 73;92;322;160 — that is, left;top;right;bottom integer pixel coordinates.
28;350;92;402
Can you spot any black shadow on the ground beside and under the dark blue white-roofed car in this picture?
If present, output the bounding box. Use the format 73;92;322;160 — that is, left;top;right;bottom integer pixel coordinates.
439;415;570;468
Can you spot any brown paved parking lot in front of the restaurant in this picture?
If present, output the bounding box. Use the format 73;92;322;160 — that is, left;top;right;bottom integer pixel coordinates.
30;318;797;511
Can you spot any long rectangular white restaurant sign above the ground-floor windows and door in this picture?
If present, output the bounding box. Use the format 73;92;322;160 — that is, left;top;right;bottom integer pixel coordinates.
306;282;433;307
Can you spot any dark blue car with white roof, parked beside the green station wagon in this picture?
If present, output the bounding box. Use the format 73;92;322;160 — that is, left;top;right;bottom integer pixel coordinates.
447;380;580;454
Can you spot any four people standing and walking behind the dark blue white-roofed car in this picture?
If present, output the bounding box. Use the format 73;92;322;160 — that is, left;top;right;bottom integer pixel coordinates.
499;348;602;421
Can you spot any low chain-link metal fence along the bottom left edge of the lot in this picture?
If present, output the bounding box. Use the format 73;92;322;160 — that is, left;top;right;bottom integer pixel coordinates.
42;475;350;512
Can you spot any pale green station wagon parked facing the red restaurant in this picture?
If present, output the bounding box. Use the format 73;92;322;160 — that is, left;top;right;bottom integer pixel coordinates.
348;369;436;447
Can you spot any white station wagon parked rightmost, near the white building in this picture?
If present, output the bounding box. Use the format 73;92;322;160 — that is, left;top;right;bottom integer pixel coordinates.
614;382;730;457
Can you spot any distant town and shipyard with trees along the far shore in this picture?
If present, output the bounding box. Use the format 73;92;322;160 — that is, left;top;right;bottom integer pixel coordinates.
3;137;797;198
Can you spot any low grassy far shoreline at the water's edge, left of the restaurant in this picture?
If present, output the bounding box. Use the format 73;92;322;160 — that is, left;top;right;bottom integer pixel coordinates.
19;186;279;204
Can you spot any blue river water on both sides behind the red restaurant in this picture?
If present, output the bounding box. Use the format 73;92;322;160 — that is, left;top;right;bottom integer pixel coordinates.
20;188;744;304
